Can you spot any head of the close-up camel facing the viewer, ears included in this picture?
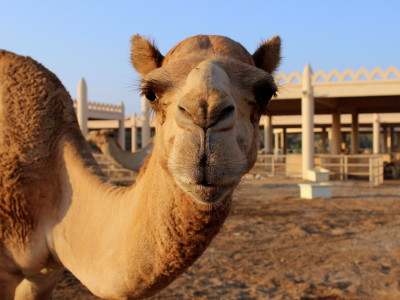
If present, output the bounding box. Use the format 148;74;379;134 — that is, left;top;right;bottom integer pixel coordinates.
131;35;280;204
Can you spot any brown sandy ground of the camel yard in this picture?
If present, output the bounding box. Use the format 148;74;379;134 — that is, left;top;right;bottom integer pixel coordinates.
53;178;400;300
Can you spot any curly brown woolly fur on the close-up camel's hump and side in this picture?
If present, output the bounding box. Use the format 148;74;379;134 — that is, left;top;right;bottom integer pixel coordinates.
0;51;75;240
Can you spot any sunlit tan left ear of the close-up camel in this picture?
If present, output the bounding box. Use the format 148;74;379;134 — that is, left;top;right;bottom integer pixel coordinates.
131;34;164;76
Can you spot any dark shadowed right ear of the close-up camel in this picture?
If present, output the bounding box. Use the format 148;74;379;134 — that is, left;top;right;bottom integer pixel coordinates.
253;36;281;74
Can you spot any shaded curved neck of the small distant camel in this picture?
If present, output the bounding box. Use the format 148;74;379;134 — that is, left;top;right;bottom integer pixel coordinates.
101;139;152;171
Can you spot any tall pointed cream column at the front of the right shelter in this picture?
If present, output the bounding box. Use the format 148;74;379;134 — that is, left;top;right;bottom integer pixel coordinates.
301;64;314;179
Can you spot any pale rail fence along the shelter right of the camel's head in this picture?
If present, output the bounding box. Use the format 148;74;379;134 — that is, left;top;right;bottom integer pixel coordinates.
252;154;384;186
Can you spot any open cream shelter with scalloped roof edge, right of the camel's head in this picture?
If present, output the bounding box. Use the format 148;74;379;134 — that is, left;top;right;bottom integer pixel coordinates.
265;65;400;176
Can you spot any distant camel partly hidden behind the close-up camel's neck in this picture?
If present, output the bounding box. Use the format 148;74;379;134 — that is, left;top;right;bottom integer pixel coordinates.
86;129;153;172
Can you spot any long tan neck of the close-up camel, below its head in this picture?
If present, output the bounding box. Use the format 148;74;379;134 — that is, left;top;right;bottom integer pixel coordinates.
51;138;231;298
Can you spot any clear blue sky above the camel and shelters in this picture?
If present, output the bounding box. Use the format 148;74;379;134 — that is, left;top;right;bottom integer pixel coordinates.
0;0;400;114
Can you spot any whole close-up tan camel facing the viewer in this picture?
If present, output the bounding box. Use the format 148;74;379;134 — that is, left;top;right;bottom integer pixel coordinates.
0;35;280;300
